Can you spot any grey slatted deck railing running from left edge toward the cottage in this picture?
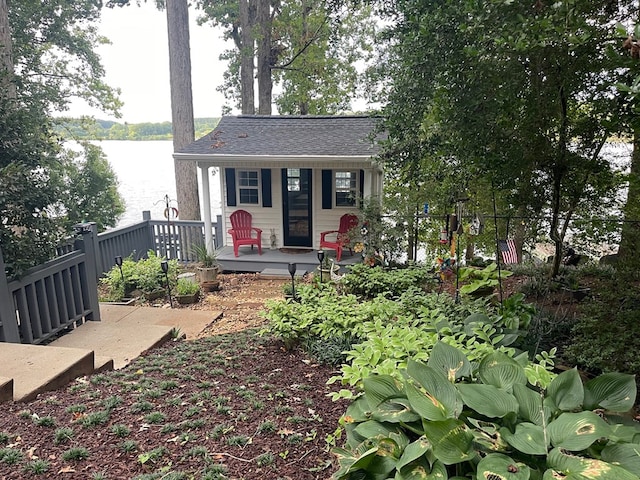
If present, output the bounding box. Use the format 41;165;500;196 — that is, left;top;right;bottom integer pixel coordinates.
0;212;222;344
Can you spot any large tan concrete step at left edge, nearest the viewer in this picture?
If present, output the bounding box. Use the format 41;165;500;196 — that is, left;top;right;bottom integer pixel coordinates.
0;343;94;402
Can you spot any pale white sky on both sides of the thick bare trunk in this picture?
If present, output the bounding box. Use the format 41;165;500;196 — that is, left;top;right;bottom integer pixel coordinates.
65;2;230;123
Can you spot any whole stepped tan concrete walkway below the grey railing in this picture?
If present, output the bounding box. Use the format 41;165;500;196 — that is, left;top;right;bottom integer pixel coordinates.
0;304;222;403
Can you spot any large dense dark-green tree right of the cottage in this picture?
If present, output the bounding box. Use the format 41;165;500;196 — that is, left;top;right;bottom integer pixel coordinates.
378;0;620;273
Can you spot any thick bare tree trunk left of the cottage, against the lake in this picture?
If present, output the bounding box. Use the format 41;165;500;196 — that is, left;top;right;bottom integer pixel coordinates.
166;0;200;220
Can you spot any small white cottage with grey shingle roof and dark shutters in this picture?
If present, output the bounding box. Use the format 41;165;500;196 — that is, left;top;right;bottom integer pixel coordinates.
174;115;382;255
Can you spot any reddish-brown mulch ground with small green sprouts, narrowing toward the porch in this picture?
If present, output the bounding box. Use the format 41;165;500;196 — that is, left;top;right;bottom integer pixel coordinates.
0;275;347;480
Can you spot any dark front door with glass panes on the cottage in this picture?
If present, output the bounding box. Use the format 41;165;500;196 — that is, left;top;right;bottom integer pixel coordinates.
282;168;312;247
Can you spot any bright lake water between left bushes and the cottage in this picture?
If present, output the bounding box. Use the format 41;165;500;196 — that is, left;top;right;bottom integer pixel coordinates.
94;140;221;227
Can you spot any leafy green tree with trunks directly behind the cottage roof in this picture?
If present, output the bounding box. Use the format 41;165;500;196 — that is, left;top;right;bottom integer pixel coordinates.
198;0;375;115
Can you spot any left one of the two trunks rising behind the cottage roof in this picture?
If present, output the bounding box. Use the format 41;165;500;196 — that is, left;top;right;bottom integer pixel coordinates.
240;0;256;115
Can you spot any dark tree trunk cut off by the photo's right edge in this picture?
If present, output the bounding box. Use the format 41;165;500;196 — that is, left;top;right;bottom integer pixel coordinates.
618;127;640;276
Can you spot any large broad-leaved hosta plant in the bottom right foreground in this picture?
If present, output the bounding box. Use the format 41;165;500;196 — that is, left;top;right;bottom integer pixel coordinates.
333;343;640;480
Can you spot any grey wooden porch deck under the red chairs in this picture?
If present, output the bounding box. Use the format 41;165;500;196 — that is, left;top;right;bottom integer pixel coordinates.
218;245;362;277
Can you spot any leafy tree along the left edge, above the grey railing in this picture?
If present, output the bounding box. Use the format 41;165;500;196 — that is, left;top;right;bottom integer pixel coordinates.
0;0;124;274
